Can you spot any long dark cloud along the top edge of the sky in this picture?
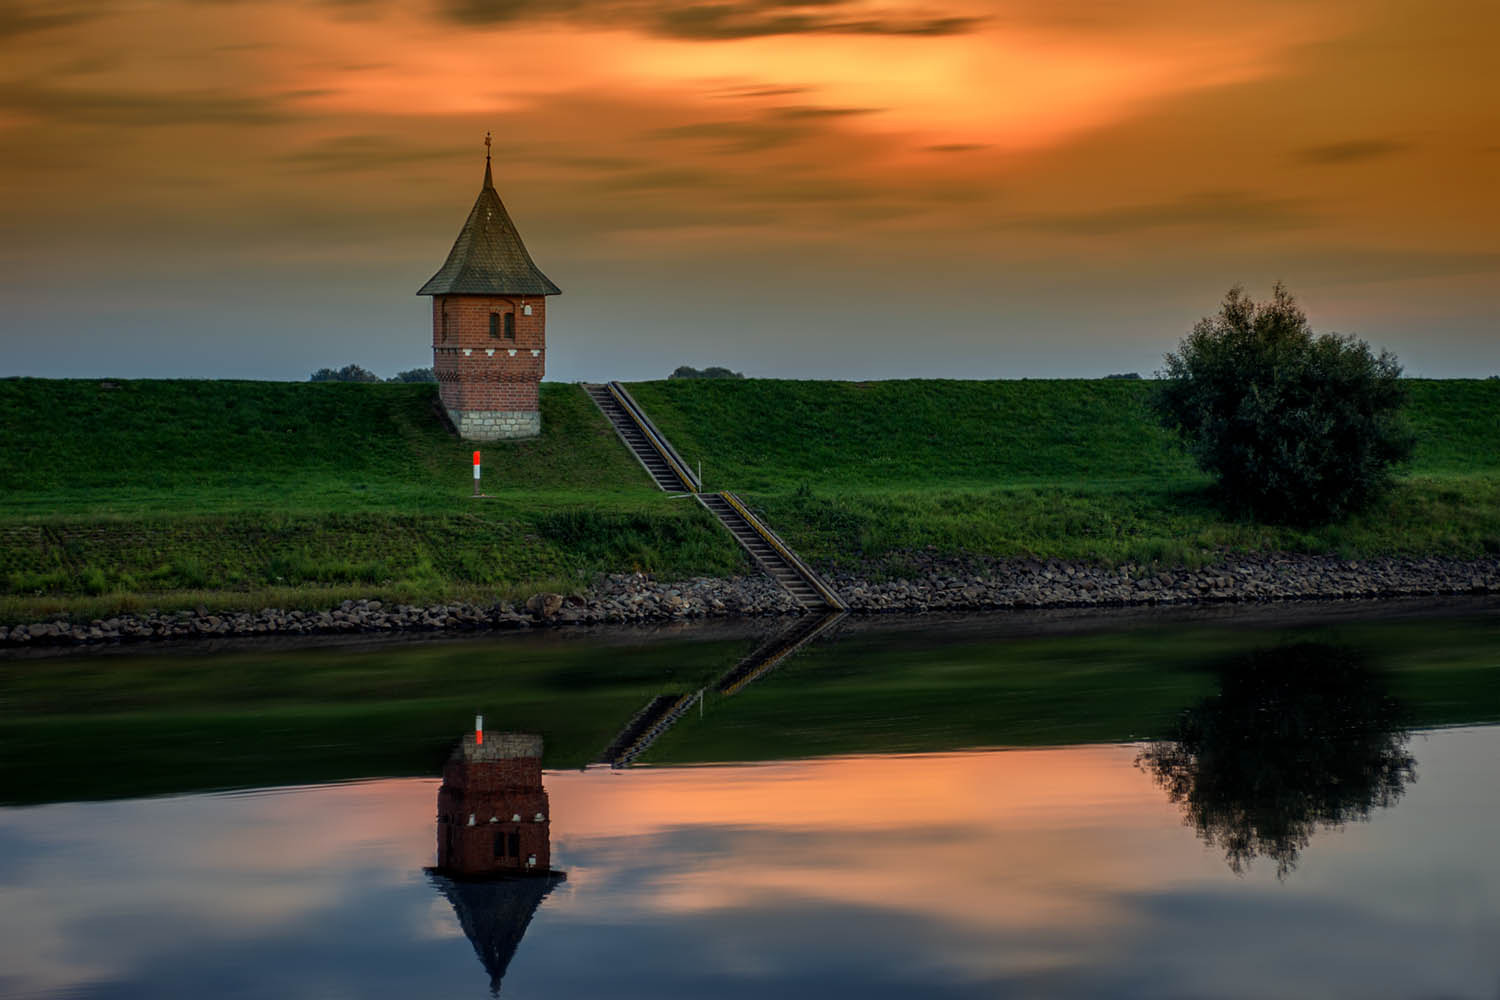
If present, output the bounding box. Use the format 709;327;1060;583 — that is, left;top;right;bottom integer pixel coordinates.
443;0;981;40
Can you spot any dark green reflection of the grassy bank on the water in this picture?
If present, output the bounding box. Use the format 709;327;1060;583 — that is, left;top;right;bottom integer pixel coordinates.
0;615;1500;804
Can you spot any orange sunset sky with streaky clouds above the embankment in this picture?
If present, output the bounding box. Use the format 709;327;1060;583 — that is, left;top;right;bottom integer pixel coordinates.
0;0;1500;379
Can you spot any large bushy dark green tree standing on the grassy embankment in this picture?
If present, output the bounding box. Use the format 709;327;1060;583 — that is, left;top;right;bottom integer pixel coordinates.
1154;282;1413;525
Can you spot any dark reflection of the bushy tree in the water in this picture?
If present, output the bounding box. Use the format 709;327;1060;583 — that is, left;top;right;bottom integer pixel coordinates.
1137;643;1416;879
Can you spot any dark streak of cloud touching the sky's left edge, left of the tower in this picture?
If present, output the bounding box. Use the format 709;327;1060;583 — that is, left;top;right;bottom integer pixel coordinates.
0;81;301;126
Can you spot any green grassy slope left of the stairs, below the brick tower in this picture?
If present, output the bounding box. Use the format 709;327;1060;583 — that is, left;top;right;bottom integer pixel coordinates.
0;379;743;621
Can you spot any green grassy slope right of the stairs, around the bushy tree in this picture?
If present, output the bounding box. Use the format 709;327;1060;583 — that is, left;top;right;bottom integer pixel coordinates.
632;379;1500;574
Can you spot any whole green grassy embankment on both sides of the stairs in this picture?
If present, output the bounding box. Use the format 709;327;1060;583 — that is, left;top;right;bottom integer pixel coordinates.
0;379;1500;621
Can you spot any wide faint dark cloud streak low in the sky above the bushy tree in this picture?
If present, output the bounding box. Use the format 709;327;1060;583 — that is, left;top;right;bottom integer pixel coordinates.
1011;190;1314;235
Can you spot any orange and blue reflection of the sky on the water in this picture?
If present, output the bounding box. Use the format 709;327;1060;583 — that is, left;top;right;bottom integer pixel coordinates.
0;727;1500;997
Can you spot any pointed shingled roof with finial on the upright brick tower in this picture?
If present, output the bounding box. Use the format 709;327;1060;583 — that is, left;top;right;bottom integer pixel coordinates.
417;156;563;295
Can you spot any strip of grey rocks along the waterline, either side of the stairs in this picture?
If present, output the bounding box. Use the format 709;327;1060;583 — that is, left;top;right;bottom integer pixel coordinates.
0;553;1500;648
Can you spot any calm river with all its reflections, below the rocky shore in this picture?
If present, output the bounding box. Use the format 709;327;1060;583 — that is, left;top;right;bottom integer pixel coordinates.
0;601;1500;1000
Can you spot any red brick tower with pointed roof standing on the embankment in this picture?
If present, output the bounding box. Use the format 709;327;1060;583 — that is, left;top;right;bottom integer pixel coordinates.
417;135;561;441
